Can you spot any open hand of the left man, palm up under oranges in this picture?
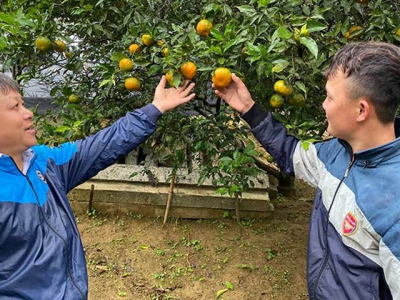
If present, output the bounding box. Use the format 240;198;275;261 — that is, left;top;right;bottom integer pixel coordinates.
153;76;195;113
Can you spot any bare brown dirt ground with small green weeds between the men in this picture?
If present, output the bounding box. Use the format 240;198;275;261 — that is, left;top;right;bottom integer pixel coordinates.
76;182;313;300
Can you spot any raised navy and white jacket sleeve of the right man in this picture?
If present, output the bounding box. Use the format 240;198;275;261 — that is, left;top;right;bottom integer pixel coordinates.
242;103;324;186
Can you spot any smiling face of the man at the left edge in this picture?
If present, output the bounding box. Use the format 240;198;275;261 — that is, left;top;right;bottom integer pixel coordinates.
0;91;37;156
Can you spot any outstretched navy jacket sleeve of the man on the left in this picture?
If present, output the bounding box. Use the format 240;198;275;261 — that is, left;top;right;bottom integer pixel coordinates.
55;104;161;192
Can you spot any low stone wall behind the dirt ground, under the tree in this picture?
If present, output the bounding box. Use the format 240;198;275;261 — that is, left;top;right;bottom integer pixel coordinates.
69;164;277;218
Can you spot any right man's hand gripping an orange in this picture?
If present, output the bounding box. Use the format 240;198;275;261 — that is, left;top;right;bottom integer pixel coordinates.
212;74;254;114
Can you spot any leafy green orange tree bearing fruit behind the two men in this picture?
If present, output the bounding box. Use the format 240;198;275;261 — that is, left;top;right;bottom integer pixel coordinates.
0;0;400;195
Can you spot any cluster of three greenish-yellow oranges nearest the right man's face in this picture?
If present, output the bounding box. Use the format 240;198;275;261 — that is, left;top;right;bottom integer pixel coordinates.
269;79;305;108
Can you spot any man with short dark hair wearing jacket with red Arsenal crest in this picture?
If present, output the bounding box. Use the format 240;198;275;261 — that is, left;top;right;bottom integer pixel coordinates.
214;42;400;300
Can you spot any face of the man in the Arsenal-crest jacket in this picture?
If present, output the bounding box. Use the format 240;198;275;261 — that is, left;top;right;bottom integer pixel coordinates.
322;70;359;142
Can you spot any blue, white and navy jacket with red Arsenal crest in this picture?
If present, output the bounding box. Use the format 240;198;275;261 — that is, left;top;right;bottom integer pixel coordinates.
242;104;400;300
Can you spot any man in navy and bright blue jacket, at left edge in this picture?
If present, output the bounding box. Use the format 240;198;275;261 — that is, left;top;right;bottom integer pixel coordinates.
0;73;194;300
